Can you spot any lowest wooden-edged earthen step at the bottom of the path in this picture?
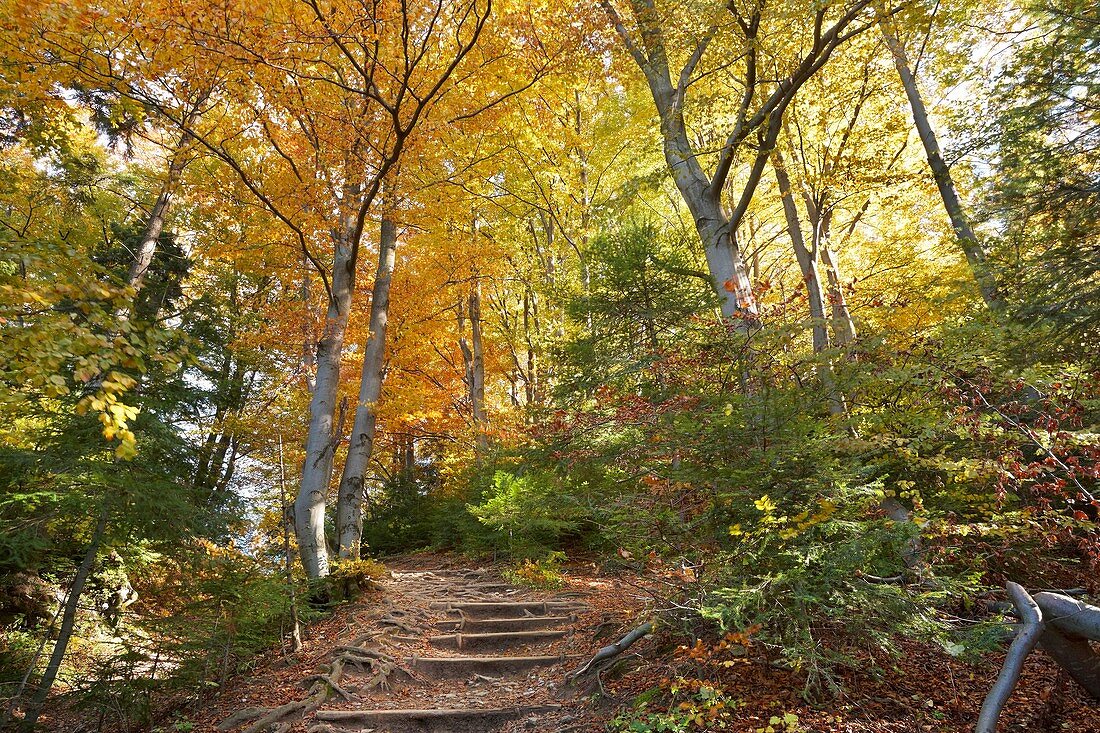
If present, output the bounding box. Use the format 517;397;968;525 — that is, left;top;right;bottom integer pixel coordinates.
314;704;561;733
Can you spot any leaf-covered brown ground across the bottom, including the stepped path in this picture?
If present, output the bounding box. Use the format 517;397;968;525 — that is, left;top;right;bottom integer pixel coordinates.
148;555;1100;733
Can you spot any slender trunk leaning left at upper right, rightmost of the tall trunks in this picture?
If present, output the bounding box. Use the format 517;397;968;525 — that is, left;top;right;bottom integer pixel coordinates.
879;12;1001;309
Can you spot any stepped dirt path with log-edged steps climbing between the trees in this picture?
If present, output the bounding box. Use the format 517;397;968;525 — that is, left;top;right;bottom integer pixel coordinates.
305;569;593;733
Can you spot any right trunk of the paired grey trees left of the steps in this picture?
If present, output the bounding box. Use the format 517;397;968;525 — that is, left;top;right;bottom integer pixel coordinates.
337;216;397;559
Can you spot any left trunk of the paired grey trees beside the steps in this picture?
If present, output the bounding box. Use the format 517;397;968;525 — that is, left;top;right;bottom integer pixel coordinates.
294;222;355;579
